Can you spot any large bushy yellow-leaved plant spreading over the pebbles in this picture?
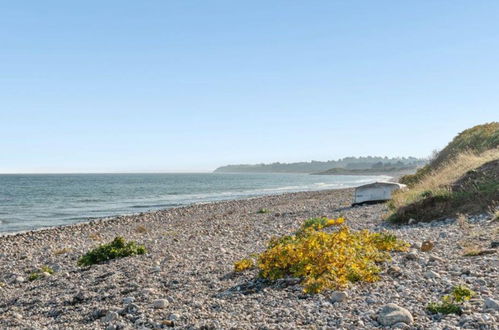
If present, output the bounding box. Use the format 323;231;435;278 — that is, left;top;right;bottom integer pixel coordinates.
235;218;408;293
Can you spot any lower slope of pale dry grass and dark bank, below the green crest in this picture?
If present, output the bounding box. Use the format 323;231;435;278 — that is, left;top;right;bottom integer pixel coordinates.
388;148;499;223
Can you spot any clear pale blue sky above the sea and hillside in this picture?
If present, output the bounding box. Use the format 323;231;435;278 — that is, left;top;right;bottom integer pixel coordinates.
0;0;499;172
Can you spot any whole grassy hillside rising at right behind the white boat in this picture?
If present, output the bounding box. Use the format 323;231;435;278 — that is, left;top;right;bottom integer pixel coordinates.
388;123;499;223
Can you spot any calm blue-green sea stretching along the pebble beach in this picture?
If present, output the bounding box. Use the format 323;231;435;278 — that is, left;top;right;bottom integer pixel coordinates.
0;173;386;233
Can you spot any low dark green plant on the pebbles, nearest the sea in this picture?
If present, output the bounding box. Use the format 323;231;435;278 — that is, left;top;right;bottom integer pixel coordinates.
78;237;147;266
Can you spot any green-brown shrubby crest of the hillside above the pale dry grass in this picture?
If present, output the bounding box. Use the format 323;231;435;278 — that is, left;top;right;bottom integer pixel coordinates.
399;122;499;187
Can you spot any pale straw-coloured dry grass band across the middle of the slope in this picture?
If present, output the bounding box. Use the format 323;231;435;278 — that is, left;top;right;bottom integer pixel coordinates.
392;149;499;209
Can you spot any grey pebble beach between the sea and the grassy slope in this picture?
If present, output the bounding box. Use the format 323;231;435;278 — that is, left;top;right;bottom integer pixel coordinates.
0;189;499;329
